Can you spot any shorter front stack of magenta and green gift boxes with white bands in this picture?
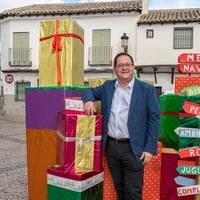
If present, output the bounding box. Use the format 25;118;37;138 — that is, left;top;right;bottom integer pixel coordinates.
47;97;103;200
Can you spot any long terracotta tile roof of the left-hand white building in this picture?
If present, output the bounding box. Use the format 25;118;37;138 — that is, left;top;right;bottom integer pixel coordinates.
0;0;142;18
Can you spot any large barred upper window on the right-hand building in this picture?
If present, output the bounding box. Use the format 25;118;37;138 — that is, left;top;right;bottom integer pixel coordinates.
174;27;193;49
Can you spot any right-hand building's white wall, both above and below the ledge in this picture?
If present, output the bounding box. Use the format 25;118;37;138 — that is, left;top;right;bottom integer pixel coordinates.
135;23;200;92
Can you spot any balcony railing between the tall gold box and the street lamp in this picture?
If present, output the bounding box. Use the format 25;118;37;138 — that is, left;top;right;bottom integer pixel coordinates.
88;46;112;66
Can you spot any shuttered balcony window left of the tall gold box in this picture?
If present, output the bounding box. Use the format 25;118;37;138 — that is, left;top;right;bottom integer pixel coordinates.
10;32;31;66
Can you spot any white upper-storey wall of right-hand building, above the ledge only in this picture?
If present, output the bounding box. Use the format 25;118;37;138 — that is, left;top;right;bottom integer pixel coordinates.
136;23;200;65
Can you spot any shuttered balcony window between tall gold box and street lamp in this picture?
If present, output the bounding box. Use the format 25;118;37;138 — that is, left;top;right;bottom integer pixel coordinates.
89;29;112;65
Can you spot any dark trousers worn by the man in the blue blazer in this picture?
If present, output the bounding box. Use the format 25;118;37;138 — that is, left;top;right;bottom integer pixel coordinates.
107;139;144;200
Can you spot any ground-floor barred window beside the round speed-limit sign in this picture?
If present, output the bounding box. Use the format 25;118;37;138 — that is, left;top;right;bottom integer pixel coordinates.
15;80;31;101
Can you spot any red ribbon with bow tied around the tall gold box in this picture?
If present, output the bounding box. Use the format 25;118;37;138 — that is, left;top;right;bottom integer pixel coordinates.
40;20;84;86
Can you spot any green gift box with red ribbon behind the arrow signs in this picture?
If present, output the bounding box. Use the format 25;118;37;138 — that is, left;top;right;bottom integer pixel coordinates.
159;94;200;150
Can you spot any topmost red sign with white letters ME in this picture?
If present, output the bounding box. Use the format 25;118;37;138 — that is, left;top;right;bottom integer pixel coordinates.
178;53;200;63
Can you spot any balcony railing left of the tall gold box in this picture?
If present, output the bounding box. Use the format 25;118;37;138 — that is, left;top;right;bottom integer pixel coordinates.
9;48;32;67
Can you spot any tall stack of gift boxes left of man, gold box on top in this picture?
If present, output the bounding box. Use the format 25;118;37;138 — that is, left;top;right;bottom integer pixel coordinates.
26;18;103;200
